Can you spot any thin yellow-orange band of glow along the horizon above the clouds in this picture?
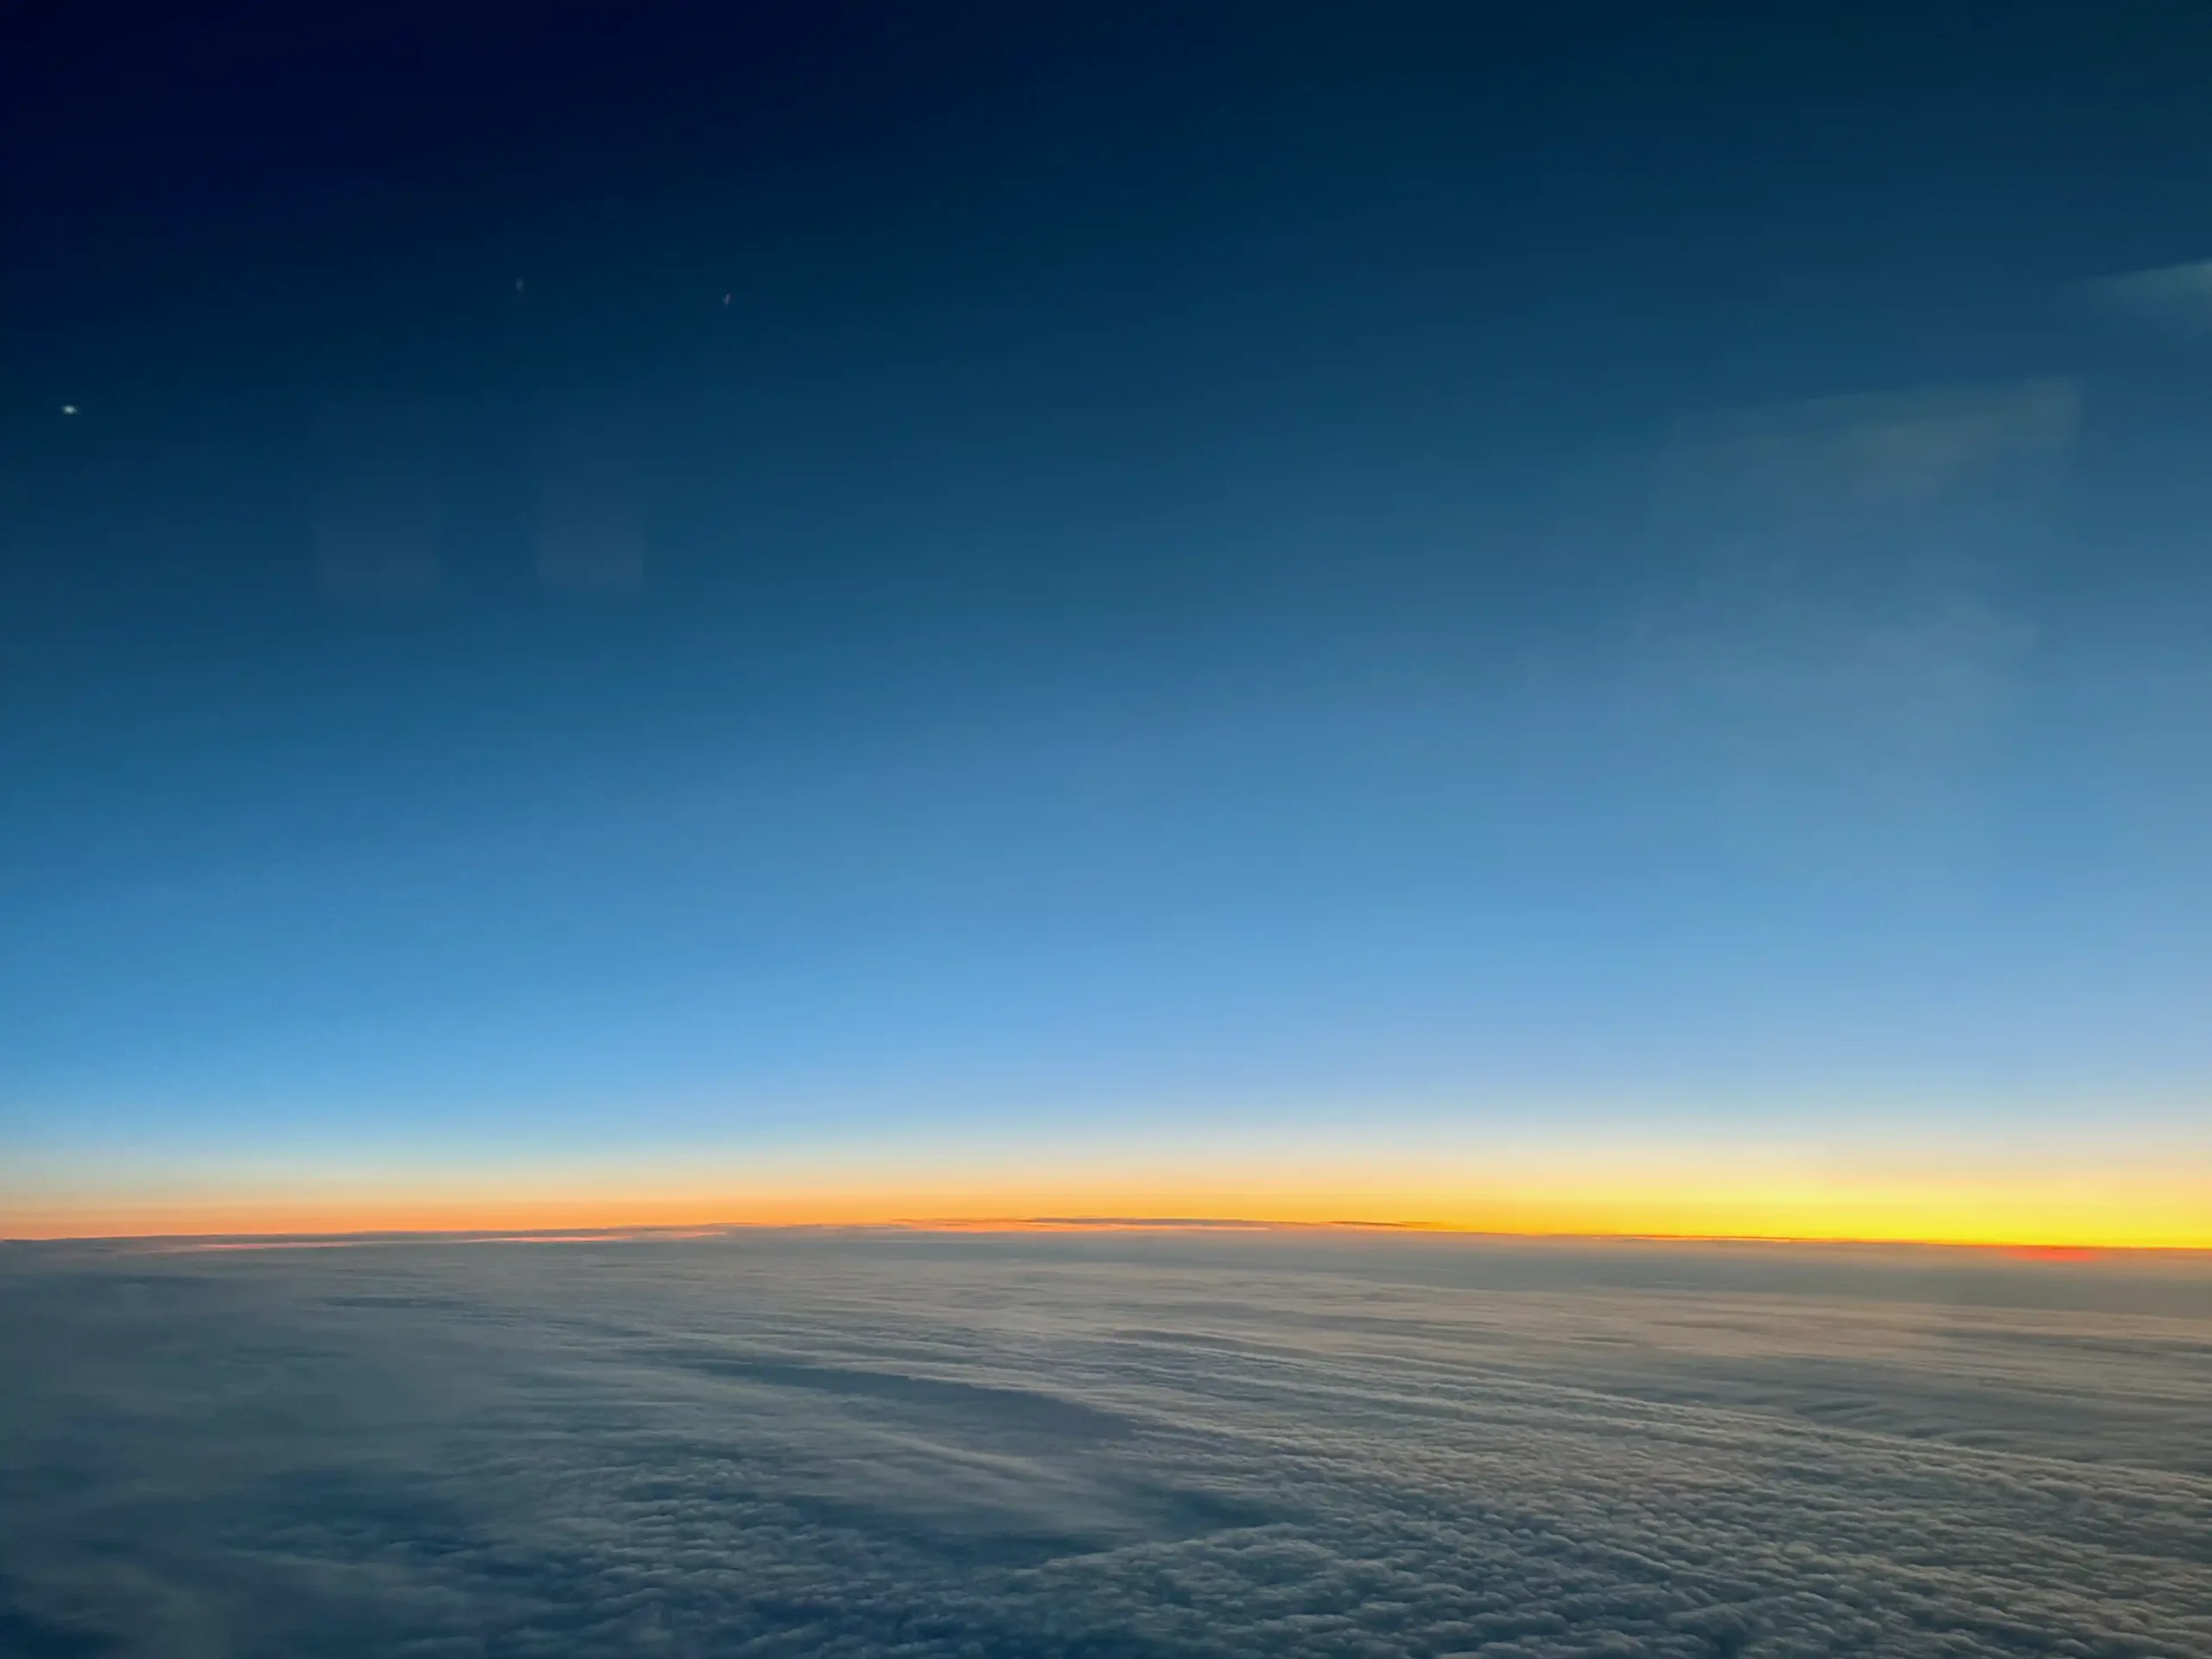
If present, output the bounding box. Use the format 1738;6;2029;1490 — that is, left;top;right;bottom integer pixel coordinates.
0;1170;2212;1259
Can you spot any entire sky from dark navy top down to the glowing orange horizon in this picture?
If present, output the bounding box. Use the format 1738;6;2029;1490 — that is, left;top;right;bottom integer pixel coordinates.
0;0;2212;1245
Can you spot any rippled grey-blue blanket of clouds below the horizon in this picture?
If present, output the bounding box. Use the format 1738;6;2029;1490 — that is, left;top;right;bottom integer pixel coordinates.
0;1234;2212;1659
